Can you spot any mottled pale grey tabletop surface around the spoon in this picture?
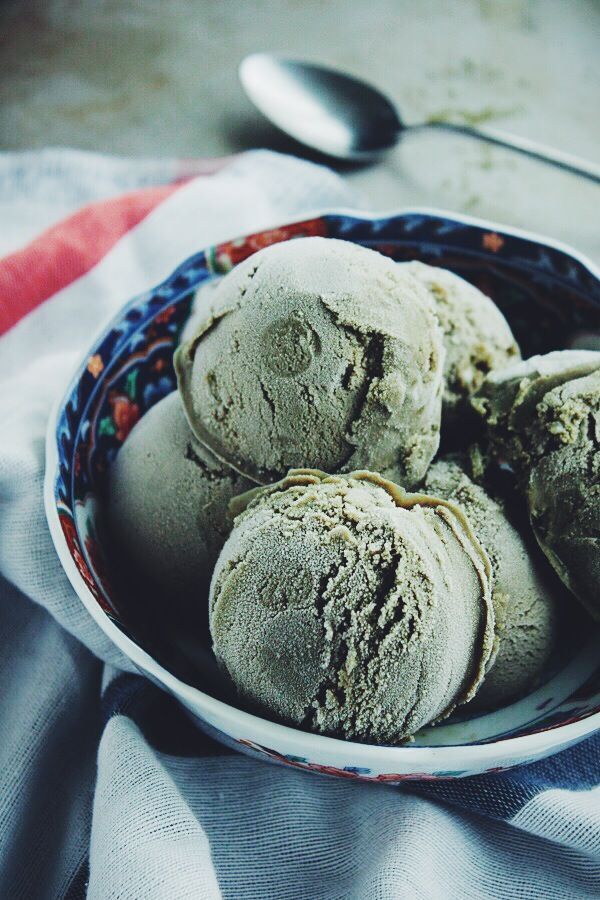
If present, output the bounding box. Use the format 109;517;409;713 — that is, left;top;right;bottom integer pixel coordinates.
0;0;600;259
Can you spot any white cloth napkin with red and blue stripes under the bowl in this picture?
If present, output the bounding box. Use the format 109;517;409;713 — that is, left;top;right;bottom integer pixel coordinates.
0;151;600;900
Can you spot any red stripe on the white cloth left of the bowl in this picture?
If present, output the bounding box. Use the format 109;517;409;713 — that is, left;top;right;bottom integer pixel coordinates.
0;179;185;335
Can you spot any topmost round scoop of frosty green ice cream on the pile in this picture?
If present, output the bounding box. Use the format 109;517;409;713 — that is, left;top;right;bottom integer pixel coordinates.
175;238;444;487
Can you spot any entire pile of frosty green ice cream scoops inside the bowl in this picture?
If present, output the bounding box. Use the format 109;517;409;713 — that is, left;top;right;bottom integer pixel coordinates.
110;238;600;743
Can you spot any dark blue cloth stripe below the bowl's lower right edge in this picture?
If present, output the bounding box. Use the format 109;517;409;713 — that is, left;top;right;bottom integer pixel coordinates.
410;733;600;819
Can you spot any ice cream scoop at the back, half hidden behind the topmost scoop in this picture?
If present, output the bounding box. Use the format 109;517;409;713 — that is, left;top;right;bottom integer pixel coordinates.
402;260;521;425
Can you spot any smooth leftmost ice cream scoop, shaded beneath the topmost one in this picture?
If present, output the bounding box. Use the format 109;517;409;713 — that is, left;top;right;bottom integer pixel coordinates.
108;391;250;600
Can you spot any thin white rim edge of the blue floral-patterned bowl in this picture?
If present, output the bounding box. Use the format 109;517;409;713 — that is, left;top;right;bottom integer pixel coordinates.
44;206;600;769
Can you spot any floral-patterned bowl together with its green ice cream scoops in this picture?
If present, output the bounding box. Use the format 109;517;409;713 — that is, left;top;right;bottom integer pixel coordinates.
45;211;600;782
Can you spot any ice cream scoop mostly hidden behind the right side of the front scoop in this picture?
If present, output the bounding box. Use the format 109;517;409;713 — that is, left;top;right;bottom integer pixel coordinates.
425;459;560;709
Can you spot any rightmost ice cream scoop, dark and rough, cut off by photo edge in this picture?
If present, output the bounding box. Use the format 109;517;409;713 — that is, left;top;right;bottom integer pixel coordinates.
474;351;600;618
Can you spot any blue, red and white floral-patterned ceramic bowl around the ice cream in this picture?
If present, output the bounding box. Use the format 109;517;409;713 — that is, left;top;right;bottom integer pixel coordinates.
45;210;600;783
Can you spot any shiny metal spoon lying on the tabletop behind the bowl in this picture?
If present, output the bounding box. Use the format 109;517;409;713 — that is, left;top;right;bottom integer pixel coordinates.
239;53;600;183
